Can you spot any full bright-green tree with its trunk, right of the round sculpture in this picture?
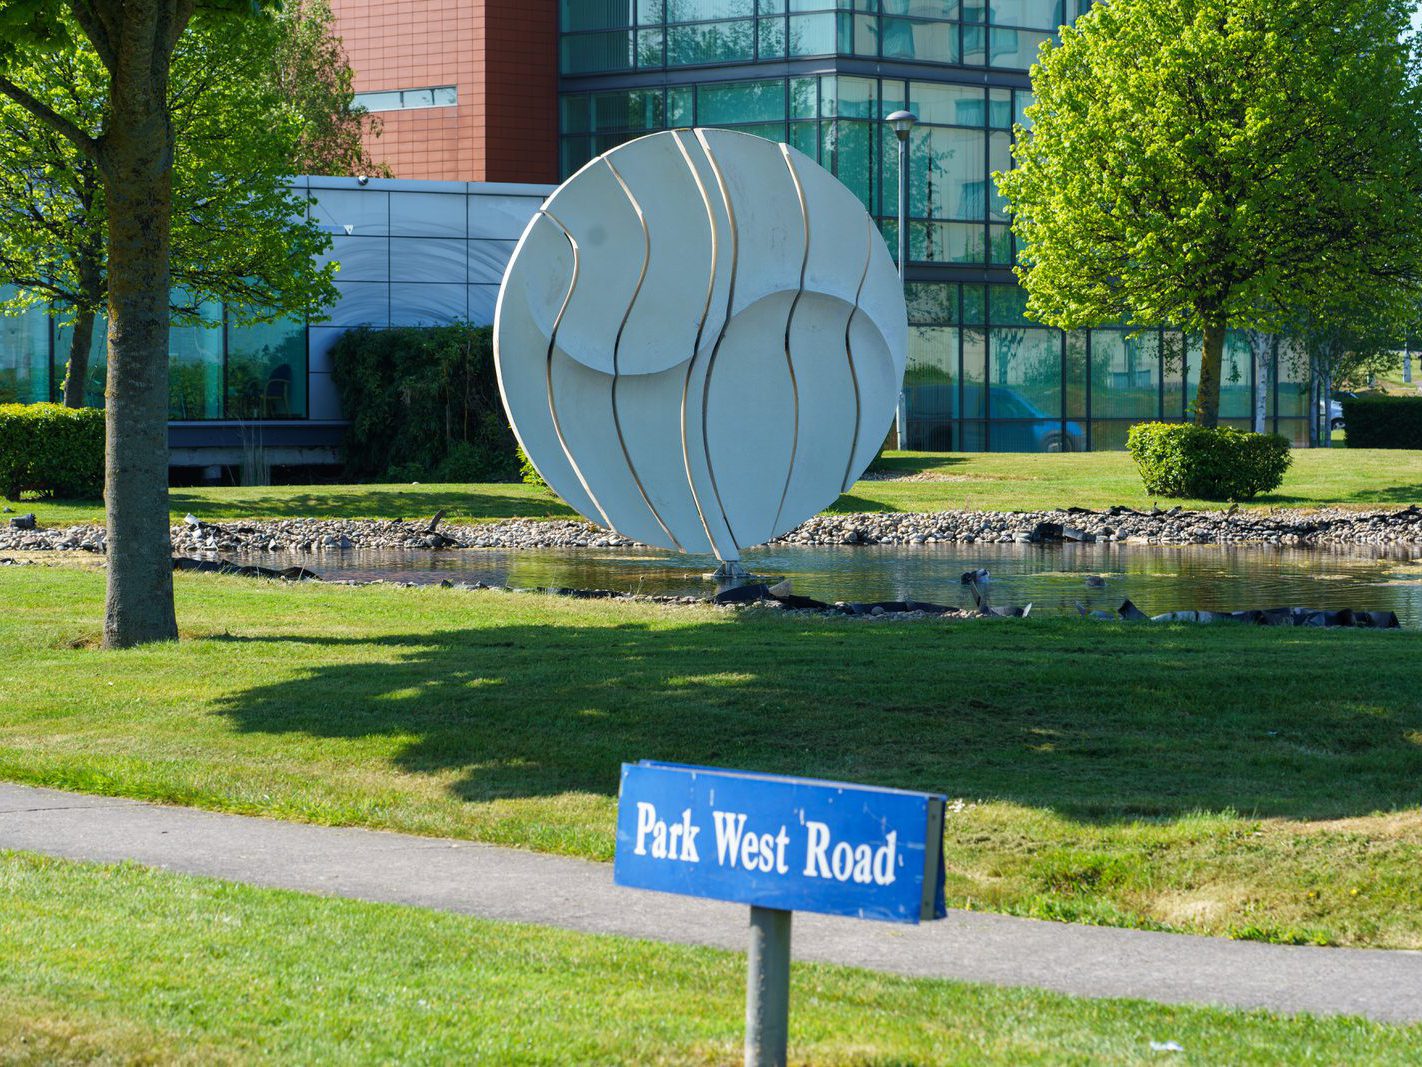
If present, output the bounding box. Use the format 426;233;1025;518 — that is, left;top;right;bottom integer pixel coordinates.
997;0;1422;425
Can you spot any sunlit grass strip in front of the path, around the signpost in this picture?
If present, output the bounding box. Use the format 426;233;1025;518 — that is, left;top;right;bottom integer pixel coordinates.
0;852;1422;1064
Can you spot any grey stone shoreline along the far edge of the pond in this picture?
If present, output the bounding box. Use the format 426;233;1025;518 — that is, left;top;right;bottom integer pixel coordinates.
0;505;1422;555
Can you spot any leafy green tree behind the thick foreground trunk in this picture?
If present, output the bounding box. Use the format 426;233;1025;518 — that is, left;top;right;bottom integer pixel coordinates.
0;7;344;407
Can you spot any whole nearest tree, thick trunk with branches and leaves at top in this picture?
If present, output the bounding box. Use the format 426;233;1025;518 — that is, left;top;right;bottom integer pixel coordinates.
0;0;282;647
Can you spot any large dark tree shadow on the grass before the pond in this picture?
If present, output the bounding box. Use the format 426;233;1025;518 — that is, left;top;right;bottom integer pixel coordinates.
210;617;1422;822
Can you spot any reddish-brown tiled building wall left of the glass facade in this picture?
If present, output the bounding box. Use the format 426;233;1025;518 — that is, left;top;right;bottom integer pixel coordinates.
331;0;557;182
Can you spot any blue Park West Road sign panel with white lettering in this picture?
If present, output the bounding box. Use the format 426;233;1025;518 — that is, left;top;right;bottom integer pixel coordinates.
613;760;946;923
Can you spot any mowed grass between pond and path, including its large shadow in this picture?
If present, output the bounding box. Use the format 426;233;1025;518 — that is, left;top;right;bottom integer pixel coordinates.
0;568;1422;949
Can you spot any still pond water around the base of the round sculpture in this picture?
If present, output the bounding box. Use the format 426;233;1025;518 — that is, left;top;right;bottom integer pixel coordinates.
242;545;1422;627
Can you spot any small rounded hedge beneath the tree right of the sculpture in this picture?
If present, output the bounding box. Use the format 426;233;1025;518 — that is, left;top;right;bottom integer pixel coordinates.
1126;423;1293;501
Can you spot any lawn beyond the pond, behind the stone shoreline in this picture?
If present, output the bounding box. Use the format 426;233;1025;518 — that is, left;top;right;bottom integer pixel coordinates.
11;448;1422;525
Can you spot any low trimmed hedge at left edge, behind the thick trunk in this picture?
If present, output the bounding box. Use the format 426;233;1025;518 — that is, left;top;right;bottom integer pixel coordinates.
0;404;104;501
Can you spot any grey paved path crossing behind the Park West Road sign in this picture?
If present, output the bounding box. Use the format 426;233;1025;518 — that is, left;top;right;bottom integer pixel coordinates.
0;784;1422;1023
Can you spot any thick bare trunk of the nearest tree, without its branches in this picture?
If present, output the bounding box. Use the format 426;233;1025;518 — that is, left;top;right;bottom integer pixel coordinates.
102;34;178;649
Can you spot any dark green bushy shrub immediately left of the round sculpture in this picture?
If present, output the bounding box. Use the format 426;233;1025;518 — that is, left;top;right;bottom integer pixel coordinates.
331;323;519;482
